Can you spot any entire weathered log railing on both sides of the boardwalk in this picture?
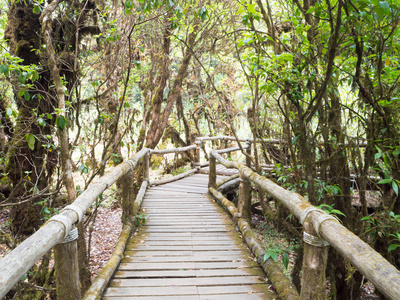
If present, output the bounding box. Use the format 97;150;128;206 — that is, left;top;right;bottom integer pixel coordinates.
0;136;388;299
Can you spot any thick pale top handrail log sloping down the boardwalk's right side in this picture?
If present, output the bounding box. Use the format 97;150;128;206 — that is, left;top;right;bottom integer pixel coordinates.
210;150;400;299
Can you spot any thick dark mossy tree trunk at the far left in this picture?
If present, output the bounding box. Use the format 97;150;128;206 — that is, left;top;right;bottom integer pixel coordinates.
5;1;57;234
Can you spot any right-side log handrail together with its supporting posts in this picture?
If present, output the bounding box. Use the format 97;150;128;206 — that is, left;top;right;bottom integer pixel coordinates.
209;149;400;300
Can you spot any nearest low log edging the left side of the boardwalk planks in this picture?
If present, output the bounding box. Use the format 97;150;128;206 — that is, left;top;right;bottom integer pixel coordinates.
83;224;134;300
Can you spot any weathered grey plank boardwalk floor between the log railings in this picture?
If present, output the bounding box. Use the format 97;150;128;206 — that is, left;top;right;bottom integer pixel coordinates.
103;174;277;300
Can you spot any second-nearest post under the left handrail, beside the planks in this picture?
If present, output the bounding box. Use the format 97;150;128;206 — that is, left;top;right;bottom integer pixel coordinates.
121;169;135;224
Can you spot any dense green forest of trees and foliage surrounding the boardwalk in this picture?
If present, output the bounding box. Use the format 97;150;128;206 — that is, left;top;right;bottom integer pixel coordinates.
0;0;400;299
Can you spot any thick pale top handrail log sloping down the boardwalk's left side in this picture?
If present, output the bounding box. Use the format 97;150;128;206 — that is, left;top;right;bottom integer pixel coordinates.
0;148;149;298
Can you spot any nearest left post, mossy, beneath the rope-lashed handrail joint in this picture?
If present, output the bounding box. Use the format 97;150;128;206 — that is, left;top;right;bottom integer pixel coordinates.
53;227;81;300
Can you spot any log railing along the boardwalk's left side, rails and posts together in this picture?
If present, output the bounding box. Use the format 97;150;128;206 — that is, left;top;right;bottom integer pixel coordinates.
0;145;200;299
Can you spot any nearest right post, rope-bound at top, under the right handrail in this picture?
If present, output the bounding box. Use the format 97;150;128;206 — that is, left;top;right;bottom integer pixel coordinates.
300;217;329;299
